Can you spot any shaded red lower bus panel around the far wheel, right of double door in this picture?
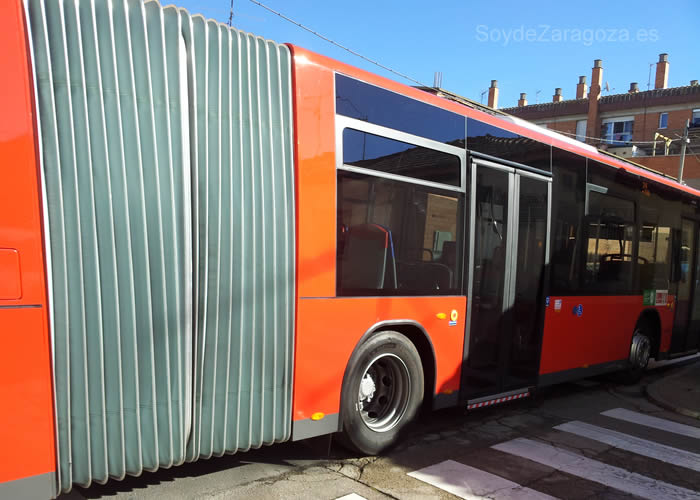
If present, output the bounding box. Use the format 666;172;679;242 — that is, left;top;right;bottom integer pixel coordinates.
540;296;673;375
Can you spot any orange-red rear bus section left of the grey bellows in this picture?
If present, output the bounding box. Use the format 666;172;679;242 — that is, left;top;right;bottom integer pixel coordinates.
0;1;56;492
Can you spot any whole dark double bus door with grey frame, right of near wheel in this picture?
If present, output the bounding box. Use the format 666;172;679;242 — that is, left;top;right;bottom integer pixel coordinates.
462;159;552;400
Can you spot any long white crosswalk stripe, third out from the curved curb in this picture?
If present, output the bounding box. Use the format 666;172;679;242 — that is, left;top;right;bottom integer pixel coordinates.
492;438;700;500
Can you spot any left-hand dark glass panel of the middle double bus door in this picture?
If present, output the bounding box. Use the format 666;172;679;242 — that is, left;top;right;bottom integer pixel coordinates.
465;168;509;393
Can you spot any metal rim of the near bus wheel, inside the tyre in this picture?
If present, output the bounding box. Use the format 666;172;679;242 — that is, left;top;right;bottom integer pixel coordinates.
357;354;411;432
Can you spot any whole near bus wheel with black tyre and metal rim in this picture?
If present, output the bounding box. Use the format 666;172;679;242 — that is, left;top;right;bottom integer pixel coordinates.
340;331;423;455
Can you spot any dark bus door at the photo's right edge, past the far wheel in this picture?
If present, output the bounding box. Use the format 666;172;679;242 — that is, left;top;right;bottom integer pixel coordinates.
671;218;700;353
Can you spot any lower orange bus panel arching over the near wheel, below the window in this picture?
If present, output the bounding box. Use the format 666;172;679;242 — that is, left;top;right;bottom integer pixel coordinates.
293;296;466;422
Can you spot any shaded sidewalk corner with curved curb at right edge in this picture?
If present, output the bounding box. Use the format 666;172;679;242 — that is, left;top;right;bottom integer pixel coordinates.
646;361;700;419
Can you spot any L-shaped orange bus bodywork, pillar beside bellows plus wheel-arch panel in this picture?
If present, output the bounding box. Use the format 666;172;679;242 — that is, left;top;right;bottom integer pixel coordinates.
290;46;466;439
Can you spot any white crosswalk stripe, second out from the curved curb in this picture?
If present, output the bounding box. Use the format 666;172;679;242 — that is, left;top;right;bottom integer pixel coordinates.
555;421;700;472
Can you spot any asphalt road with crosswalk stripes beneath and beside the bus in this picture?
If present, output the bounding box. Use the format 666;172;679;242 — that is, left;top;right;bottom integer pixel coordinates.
65;360;700;500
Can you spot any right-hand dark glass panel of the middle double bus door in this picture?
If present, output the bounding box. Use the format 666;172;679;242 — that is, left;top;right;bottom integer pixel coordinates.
506;177;548;387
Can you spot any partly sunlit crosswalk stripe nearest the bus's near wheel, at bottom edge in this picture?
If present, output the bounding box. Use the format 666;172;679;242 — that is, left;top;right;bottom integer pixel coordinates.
408;460;555;500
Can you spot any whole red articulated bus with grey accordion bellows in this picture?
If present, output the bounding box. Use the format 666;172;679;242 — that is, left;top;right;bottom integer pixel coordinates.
0;0;700;498
